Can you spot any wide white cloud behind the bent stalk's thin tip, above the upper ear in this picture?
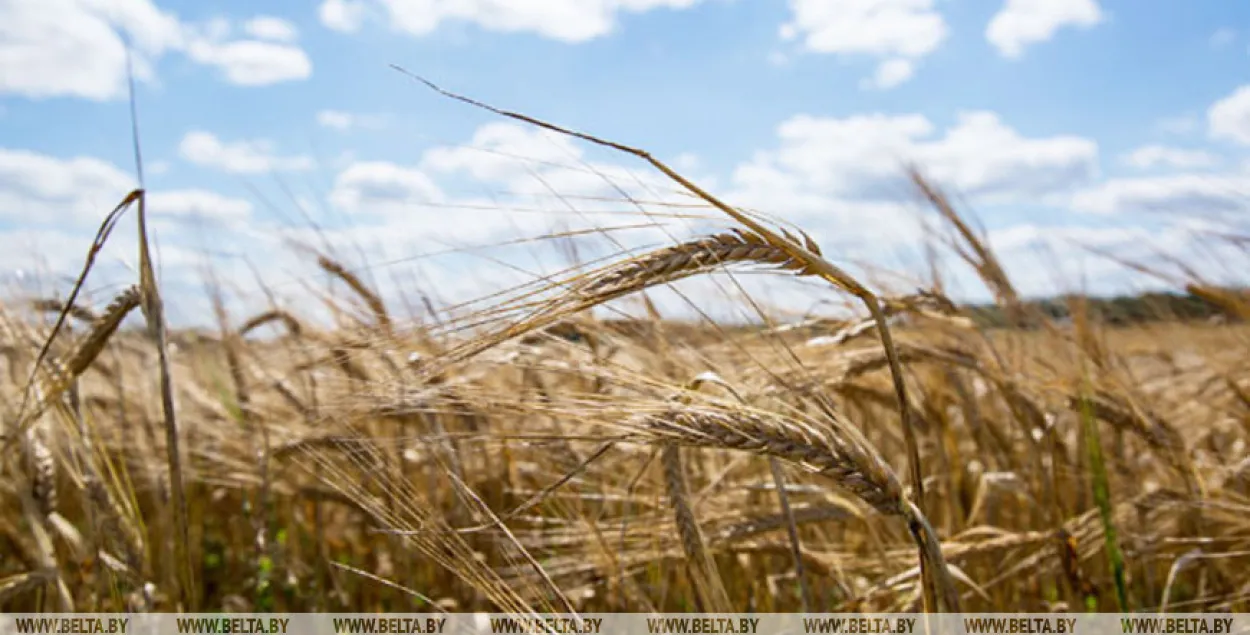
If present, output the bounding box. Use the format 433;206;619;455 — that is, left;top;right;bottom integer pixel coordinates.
320;123;708;253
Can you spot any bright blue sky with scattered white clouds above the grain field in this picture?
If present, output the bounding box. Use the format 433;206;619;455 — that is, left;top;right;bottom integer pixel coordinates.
0;0;1250;321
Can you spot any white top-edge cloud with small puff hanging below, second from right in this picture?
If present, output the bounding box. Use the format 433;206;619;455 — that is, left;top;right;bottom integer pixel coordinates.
781;0;949;89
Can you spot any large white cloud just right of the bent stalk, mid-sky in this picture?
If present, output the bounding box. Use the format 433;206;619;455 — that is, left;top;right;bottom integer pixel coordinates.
725;111;1098;266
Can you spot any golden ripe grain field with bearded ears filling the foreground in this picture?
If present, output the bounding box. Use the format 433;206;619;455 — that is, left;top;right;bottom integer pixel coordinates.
0;75;1250;613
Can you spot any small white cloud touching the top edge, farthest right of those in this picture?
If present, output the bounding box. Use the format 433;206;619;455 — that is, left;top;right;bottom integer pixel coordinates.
985;0;1104;59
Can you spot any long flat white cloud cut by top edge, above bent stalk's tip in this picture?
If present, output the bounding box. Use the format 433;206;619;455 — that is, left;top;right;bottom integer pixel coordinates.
318;0;700;43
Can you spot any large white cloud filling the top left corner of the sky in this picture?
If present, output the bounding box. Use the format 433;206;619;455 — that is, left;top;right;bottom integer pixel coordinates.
0;0;310;101
